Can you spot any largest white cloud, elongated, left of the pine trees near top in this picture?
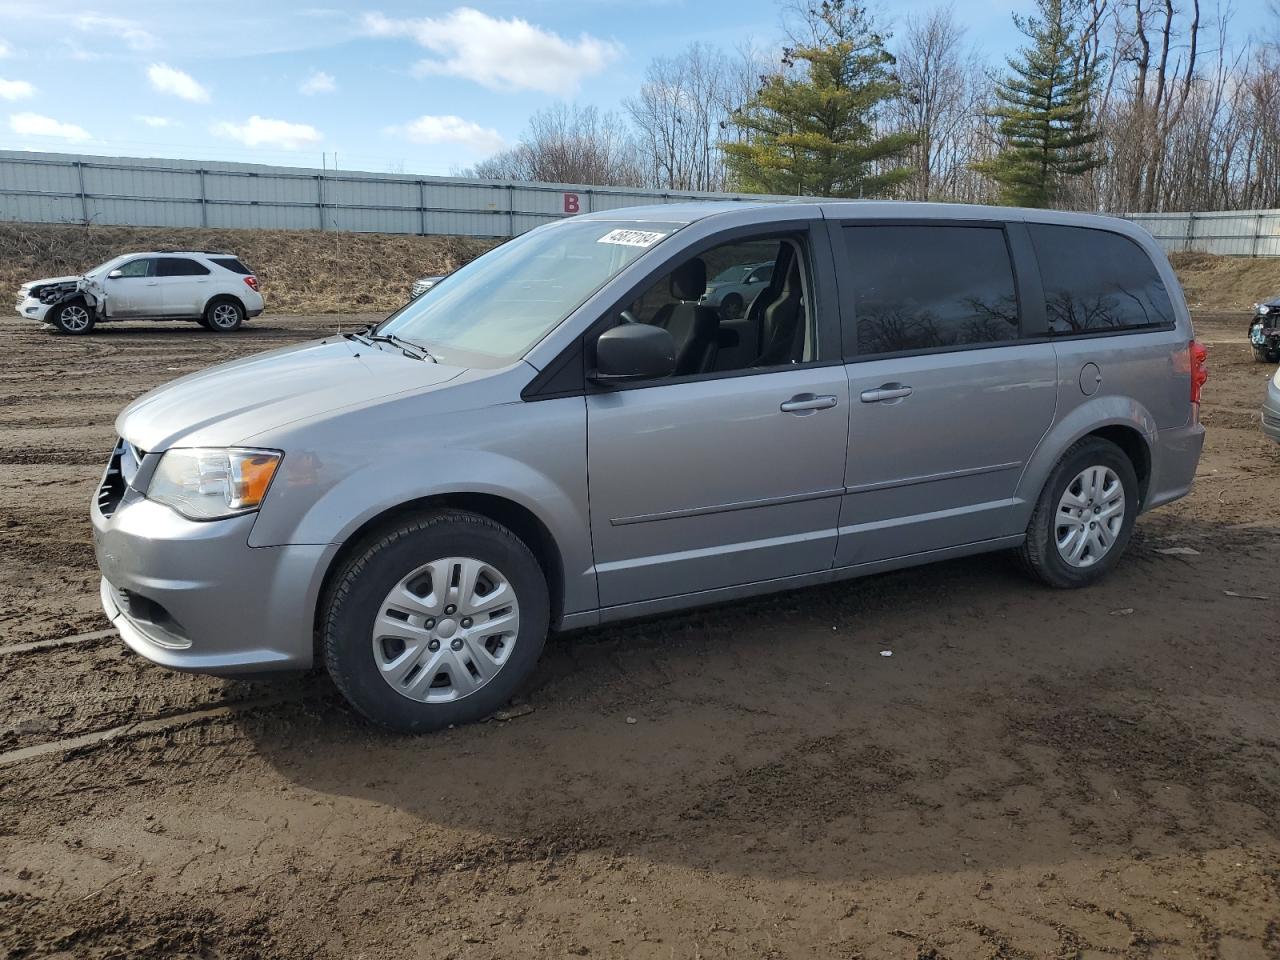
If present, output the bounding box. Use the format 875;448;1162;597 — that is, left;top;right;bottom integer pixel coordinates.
364;6;622;95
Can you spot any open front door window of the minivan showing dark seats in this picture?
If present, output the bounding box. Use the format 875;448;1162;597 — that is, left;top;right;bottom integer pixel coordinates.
625;238;815;376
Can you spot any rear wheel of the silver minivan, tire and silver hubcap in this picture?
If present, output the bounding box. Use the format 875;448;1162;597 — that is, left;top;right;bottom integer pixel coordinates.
1015;436;1139;589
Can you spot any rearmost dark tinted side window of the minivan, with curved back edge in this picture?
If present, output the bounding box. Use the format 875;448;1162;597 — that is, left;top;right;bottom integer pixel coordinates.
1028;224;1174;335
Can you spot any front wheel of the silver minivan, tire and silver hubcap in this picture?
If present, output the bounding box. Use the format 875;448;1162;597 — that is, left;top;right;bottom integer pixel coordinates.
321;511;550;733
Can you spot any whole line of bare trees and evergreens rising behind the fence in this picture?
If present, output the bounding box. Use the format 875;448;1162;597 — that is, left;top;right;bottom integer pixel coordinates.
461;0;1280;212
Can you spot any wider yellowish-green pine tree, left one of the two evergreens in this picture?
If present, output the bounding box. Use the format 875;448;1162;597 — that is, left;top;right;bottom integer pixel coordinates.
721;0;915;197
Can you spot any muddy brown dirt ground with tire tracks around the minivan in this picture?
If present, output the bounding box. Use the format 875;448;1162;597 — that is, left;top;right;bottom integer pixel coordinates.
0;315;1280;960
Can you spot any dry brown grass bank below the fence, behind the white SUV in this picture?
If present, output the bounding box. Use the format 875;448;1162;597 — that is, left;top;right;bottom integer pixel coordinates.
0;223;493;314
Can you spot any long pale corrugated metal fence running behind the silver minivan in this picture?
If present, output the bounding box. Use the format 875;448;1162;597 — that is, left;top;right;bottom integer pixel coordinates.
0;150;1280;256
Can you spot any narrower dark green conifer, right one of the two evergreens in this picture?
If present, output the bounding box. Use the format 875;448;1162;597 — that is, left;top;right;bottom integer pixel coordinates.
974;0;1103;207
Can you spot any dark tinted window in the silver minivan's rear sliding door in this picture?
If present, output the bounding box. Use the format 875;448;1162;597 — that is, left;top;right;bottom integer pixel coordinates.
845;224;1019;356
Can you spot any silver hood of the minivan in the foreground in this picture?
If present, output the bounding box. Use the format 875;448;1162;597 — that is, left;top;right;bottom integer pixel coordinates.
115;337;463;452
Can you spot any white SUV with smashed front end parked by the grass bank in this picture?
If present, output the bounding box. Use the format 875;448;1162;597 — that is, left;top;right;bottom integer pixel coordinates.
18;250;265;334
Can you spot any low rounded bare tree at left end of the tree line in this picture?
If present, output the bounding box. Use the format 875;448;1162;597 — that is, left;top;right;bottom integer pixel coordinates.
467;104;644;187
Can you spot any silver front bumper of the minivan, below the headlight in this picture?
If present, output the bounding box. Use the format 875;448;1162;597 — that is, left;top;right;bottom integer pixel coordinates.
91;481;338;675
